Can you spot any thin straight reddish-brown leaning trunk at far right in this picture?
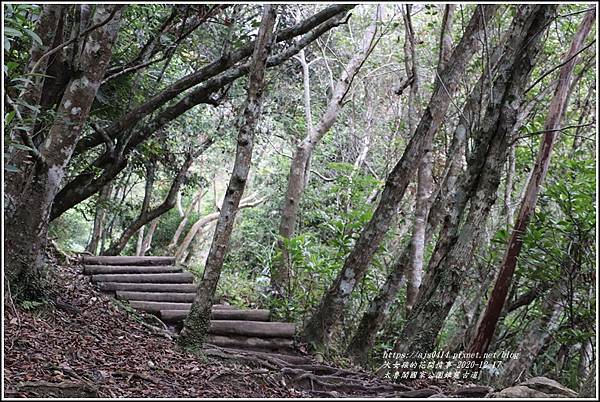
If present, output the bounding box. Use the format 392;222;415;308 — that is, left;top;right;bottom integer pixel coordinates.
470;9;596;354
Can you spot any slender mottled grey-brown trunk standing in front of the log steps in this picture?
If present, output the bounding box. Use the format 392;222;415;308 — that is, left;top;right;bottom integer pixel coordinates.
177;4;276;349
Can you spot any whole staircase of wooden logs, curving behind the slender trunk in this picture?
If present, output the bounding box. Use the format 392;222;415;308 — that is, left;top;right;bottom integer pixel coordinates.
82;256;296;354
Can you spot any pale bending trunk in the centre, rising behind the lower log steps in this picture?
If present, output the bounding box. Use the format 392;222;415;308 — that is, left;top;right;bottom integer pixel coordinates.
271;6;381;297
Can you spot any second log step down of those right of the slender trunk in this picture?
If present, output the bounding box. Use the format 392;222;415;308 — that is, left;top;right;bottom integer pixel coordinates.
208;320;296;338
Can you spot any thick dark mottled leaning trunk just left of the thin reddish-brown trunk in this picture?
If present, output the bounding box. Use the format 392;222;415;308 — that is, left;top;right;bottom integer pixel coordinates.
394;5;555;358
